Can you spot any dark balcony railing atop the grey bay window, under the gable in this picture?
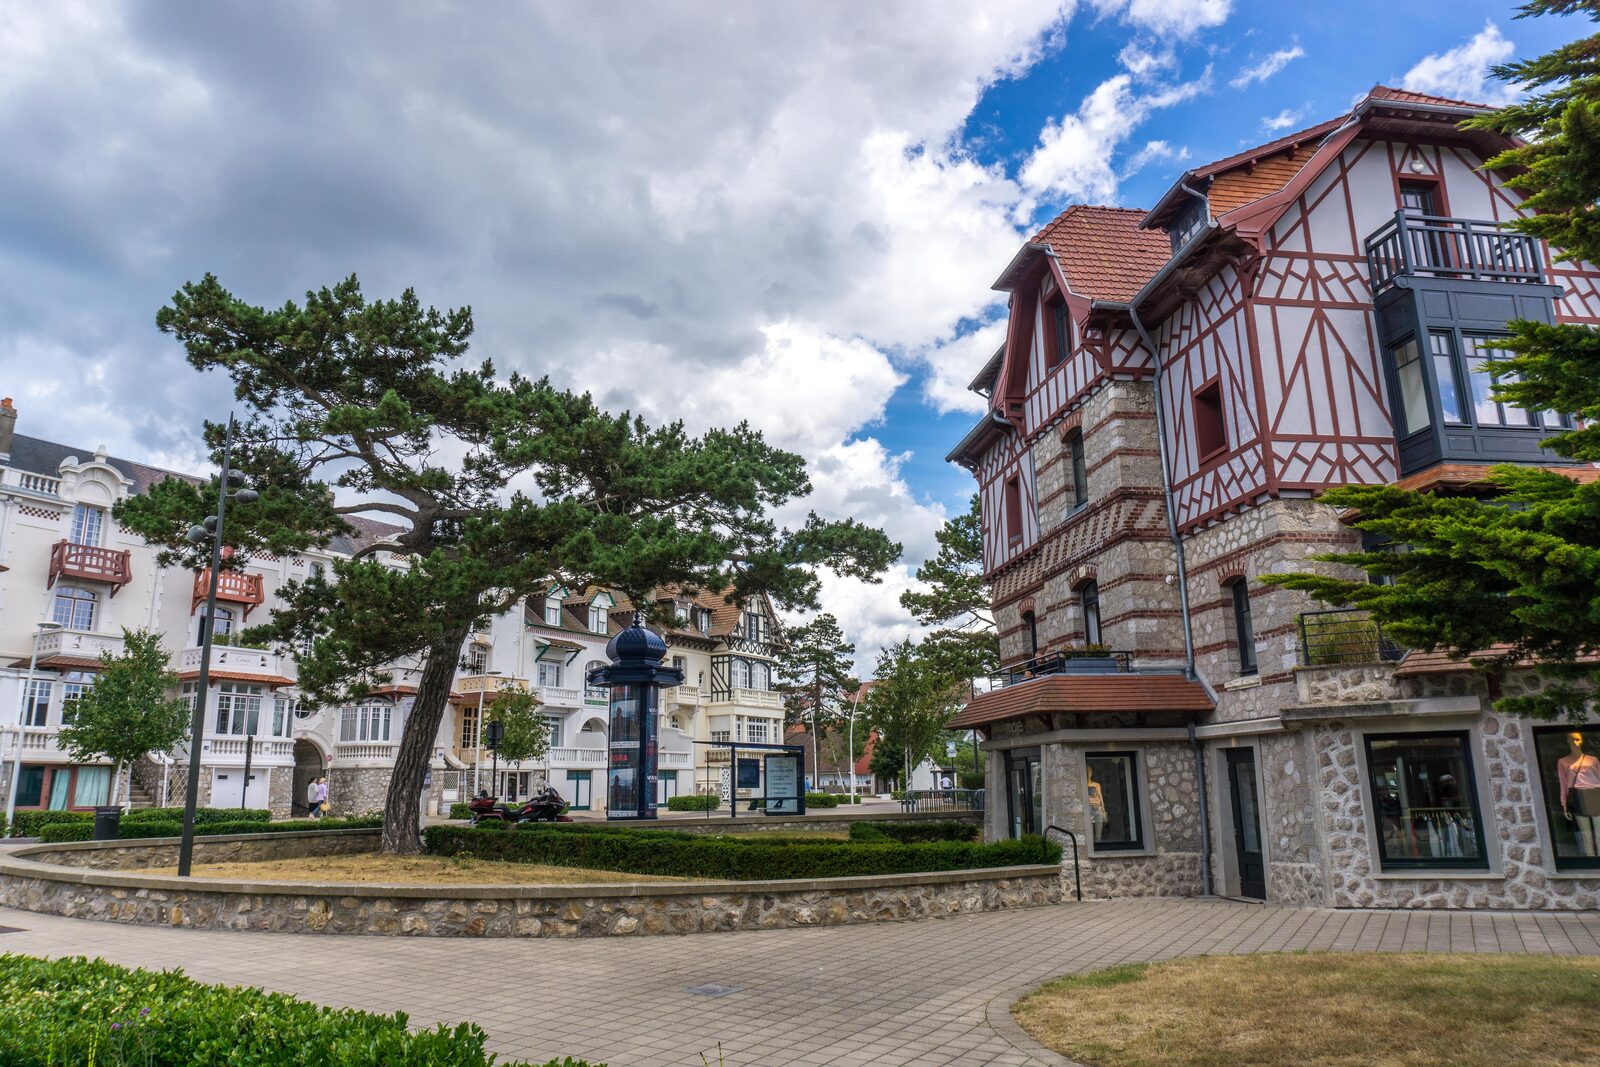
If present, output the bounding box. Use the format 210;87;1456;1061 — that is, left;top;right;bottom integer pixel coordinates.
1366;211;1544;296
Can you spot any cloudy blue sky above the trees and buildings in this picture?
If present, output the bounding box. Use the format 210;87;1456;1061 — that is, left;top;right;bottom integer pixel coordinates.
0;0;1589;661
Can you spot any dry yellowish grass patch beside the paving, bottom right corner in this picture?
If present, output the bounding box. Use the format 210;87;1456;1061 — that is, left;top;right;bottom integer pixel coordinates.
1014;953;1600;1067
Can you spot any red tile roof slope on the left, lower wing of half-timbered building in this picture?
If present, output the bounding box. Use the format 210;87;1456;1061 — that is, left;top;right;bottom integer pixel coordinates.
1030;203;1173;302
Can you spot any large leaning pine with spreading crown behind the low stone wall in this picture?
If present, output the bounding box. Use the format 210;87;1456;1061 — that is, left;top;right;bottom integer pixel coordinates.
117;275;899;853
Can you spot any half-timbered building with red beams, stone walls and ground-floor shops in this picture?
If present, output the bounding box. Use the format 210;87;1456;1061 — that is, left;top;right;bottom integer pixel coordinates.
950;86;1600;907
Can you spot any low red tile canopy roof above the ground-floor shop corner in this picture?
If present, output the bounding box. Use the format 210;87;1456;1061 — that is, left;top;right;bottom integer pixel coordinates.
950;673;1214;729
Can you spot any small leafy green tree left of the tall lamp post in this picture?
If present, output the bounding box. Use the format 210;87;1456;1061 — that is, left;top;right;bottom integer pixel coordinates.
59;630;190;803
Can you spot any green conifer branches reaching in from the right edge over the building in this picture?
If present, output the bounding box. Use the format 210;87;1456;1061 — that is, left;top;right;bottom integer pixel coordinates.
1266;0;1600;718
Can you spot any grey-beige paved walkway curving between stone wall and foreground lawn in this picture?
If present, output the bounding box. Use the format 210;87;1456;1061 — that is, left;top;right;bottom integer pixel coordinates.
0;901;1600;1067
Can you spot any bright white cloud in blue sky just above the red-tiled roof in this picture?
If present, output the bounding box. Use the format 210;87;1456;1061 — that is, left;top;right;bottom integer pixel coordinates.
1018;67;1211;203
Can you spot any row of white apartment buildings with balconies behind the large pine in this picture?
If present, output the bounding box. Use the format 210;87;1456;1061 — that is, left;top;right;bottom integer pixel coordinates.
0;400;782;816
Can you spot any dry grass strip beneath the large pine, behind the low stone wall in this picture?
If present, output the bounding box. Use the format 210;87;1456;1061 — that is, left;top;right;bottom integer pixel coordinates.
148;853;693;885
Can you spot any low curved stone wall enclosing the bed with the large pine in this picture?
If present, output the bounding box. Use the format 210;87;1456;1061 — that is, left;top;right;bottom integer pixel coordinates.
0;830;1062;937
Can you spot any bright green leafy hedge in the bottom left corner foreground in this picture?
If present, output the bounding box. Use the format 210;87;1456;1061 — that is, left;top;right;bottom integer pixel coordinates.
0;955;605;1067
